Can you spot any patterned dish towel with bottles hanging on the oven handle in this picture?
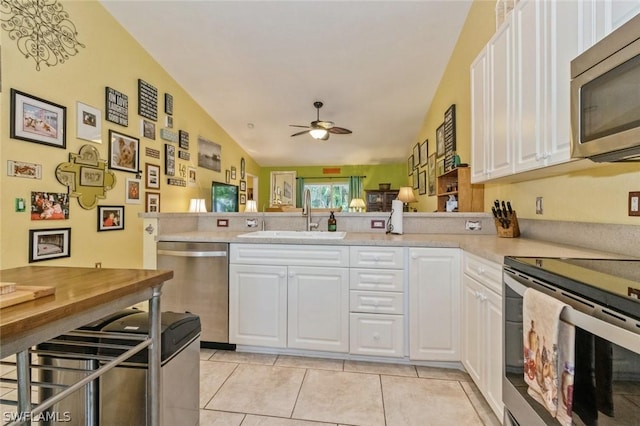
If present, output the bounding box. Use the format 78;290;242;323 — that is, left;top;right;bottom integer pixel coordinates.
522;288;575;425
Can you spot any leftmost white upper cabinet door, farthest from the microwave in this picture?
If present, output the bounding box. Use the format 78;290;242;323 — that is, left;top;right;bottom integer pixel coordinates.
471;48;490;183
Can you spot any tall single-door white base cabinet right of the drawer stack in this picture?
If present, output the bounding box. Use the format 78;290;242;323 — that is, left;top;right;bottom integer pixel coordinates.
409;248;461;361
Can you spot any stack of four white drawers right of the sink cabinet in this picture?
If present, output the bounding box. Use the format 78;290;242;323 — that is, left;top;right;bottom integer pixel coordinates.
349;246;405;357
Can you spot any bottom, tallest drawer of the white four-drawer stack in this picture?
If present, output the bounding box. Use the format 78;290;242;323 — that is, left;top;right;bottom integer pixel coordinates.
349;314;404;357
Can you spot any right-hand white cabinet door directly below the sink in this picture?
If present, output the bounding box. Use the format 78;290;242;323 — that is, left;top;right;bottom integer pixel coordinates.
288;266;349;352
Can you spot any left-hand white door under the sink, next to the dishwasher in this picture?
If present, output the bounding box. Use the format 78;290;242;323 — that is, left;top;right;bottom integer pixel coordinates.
229;264;287;348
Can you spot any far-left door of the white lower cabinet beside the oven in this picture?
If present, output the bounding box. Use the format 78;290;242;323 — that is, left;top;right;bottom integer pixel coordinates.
462;275;483;386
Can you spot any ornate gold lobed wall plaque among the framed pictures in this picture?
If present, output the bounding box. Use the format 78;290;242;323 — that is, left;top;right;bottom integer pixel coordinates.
56;145;116;210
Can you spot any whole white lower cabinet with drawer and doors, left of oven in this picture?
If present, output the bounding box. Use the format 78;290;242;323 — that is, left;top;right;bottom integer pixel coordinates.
462;253;504;418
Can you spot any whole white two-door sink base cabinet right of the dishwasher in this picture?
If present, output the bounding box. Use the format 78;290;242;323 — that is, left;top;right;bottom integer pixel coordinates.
229;244;349;352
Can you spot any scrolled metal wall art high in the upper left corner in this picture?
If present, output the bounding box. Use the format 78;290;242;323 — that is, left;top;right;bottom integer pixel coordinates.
0;0;85;71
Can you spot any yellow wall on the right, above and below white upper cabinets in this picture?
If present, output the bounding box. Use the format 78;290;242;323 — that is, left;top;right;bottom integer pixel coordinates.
408;0;640;225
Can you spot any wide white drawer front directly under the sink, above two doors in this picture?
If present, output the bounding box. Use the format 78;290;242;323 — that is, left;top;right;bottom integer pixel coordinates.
229;244;349;268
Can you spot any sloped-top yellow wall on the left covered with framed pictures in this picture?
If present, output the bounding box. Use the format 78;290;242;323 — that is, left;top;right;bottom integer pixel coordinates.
0;1;259;268
